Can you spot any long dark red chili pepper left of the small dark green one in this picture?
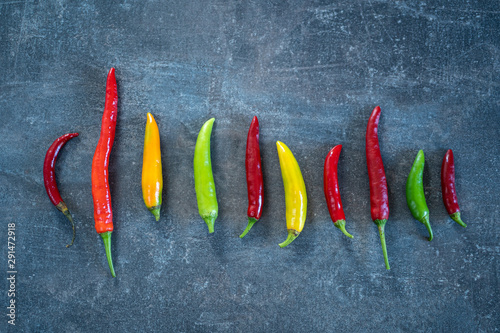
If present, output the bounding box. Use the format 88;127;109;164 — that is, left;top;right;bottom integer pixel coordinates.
366;106;390;269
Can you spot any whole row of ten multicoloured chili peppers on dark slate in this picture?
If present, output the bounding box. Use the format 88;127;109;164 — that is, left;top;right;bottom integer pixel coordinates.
43;68;466;277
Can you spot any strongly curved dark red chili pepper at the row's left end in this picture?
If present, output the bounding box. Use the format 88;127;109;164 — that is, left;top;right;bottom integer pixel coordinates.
43;133;78;247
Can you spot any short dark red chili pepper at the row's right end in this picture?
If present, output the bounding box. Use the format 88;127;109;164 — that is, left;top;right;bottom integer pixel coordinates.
441;149;467;228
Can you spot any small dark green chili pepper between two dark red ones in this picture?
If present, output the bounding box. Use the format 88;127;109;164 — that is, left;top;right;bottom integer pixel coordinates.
406;150;433;241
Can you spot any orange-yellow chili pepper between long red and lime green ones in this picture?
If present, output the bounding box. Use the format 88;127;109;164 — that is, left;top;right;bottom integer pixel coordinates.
142;112;163;221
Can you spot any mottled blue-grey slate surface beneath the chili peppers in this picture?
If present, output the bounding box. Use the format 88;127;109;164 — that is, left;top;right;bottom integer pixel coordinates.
0;0;500;332
